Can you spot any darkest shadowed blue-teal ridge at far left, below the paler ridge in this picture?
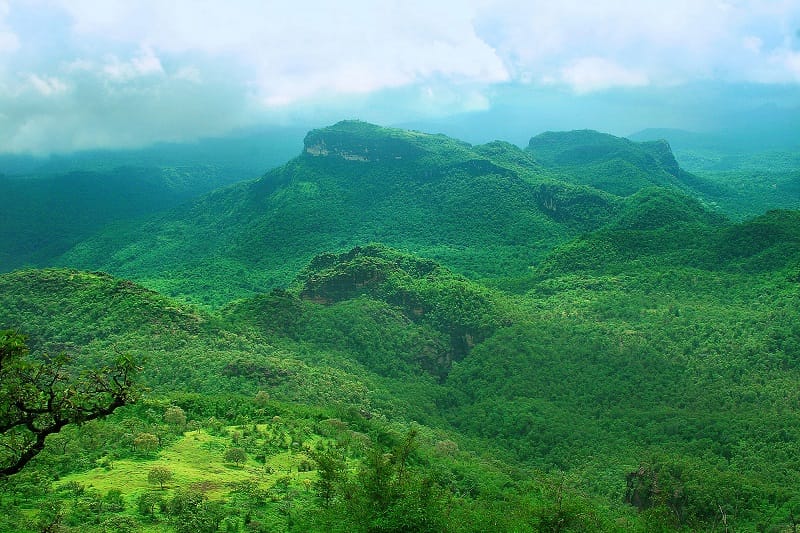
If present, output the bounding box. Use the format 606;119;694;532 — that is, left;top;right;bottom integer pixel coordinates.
0;167;214;272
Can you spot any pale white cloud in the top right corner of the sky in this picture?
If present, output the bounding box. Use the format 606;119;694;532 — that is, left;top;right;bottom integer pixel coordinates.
478;0;800;91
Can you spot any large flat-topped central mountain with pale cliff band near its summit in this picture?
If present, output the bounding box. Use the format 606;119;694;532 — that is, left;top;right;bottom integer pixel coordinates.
61;121;648;304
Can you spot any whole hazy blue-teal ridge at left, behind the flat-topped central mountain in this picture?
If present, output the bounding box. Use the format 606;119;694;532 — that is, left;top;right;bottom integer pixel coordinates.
0;128;302;272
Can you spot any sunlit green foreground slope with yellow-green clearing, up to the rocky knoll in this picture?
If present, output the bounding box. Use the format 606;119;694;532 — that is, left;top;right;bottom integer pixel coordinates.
0;264;634;531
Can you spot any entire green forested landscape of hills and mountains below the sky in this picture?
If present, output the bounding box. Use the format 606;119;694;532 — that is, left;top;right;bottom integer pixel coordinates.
0;121;800;532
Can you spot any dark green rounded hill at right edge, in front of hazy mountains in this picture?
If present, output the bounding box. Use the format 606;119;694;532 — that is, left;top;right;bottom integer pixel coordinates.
539;202;800;276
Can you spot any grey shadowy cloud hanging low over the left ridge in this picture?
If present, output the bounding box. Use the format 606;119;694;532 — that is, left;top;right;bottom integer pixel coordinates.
0;45;254;154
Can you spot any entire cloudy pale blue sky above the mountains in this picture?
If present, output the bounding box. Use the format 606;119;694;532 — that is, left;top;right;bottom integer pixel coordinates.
0;0;800;155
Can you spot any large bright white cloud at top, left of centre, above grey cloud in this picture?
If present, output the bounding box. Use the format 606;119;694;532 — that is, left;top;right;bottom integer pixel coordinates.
51;0;508;105
